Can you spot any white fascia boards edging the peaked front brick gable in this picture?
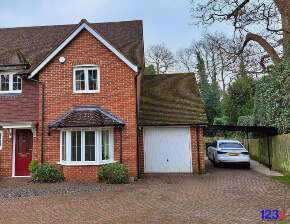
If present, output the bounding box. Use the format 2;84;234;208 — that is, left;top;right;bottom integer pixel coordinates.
29;23;138;78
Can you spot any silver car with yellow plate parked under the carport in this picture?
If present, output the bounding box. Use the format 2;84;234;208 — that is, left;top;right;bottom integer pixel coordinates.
208;140;250;168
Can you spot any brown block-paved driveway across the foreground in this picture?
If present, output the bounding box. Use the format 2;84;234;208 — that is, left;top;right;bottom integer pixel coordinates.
0;158;290;223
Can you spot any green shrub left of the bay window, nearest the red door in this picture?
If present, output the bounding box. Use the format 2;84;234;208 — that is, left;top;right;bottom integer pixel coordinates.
32;164;64;182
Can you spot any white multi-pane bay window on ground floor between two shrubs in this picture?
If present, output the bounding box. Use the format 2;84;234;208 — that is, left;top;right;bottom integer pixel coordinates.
60;128;114;165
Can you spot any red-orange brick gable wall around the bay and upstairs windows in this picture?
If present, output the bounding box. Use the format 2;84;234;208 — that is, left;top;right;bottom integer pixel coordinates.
30;30;137;180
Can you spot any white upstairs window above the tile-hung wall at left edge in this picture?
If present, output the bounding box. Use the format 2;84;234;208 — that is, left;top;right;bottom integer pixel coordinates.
0;73;22;94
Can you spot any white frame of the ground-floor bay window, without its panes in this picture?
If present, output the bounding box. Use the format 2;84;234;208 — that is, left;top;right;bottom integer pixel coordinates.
59;127;117;165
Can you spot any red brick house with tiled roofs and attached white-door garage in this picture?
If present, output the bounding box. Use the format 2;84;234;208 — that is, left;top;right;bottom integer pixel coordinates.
0;20;207;181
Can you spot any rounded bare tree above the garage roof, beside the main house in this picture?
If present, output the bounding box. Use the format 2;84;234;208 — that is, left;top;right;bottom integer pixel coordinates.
145;44;176;74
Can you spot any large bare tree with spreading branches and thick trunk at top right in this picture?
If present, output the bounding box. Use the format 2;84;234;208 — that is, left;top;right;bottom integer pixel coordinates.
191;0;290;68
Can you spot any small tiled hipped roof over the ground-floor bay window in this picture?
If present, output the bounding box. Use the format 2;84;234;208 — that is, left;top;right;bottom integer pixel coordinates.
48;106;125;128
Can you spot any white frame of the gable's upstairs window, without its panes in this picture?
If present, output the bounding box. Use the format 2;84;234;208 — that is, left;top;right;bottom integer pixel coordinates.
73;65;100;93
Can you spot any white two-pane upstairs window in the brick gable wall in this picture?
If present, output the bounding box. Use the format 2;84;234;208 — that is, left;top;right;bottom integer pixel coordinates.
73;65;100;93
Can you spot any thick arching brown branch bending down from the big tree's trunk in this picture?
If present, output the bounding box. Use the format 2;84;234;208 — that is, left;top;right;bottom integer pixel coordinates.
238;33;280;65
